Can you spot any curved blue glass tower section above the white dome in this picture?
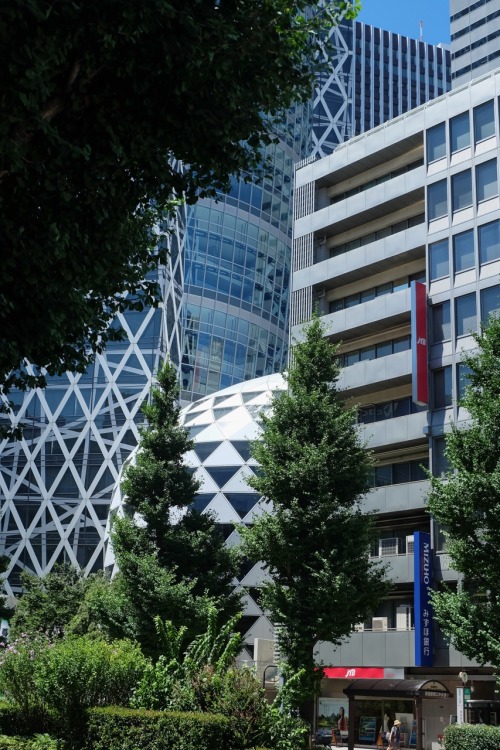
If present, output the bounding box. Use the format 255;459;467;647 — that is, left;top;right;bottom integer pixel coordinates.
182;105;311;401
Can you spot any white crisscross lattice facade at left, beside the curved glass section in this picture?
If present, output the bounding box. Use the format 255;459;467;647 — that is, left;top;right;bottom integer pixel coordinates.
0;209;185;594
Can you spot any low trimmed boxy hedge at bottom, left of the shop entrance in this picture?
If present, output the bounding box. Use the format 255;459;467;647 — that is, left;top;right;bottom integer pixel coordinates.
85;707;239;750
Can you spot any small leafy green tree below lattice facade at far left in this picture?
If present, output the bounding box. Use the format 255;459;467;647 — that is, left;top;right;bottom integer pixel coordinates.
10;564;92;638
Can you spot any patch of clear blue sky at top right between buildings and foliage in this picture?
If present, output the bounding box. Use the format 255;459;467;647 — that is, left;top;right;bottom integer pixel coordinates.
358;0;450;44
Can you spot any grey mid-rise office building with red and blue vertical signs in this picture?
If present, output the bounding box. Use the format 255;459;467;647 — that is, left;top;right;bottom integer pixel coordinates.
292;72;500;750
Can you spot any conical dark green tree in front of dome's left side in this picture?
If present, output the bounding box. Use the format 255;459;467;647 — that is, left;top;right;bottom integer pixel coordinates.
112;363;241;656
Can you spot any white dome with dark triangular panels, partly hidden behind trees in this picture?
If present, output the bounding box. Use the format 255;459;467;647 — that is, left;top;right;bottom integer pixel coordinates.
105;374;286;651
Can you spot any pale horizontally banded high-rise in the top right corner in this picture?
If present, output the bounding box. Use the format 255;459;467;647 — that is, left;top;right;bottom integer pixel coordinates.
450;0;500;88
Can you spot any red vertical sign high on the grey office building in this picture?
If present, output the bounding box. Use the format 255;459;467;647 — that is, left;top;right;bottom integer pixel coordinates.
411;281;429;406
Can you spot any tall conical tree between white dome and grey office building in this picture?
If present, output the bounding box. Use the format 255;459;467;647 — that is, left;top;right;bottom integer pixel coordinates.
241;319;386;694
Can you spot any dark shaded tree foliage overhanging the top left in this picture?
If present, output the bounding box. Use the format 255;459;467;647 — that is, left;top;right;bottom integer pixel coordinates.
0;0;357;408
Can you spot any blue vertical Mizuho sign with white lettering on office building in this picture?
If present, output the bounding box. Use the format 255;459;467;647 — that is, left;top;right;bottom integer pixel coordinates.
413;531;434;667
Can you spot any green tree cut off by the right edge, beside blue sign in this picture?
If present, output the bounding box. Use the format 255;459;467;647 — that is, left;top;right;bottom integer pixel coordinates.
428;318;500;667
